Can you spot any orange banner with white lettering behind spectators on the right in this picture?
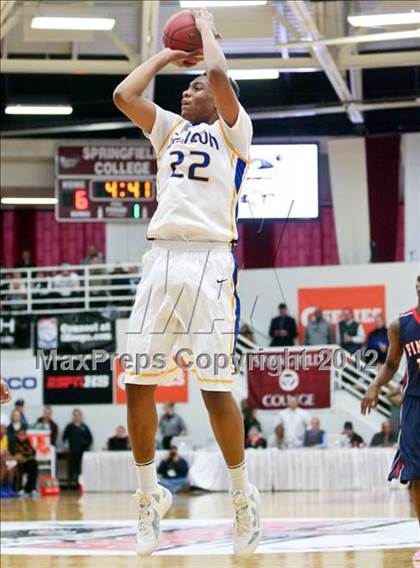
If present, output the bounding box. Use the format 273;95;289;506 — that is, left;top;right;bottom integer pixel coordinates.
298;286;386;343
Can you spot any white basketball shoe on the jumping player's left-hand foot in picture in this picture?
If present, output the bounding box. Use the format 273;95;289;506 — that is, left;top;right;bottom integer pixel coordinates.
134;485;173;556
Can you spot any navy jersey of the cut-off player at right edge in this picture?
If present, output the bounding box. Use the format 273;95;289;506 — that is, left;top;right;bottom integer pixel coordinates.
399;308;420;397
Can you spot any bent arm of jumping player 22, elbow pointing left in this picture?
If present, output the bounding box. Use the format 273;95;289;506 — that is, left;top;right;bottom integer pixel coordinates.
113;47;198;133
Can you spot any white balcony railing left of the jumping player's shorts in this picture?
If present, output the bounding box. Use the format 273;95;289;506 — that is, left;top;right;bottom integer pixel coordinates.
0;262;141;316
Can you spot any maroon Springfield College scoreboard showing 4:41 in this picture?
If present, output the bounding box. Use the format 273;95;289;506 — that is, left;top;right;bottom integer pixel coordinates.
55;143;157;222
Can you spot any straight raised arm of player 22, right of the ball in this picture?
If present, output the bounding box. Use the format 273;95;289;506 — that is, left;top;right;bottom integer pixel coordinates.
192;8;240;126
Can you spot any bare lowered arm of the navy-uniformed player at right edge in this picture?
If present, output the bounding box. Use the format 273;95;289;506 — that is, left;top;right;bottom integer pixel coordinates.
361;320;403;414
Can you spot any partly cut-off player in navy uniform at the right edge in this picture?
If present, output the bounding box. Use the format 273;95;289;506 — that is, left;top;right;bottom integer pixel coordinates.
361;275;420;561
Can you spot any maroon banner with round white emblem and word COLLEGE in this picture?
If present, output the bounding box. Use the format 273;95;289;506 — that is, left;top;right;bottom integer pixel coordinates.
248;347;333;410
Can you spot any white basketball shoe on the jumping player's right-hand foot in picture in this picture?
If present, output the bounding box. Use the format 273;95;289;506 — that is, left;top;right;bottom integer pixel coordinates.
231;485;261;556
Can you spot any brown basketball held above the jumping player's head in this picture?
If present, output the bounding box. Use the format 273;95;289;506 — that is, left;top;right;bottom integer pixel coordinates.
162;10;203;51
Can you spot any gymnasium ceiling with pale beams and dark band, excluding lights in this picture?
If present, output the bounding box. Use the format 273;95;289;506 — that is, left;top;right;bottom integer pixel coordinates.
0;0;420;138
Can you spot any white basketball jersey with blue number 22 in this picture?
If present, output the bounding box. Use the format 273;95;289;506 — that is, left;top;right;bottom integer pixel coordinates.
145;106;252;242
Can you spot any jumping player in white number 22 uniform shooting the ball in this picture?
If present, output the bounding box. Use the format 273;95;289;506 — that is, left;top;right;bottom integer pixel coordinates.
114;9;261;556
